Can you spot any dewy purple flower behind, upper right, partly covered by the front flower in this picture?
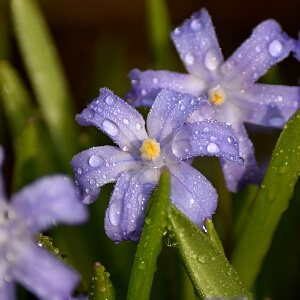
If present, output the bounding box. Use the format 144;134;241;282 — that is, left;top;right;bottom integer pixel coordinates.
127;9;299;192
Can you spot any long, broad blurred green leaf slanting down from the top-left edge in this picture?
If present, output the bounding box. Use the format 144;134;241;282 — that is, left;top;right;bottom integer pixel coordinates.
10;0;77;168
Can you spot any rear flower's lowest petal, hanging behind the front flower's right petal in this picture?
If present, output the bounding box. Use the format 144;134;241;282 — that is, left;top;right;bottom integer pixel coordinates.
220;124;262;192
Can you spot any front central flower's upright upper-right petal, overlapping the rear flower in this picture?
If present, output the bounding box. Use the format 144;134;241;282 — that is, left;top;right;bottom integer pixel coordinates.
147;89;209;143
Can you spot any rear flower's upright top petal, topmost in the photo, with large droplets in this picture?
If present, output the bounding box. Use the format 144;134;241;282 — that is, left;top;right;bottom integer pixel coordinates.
171;9;223;82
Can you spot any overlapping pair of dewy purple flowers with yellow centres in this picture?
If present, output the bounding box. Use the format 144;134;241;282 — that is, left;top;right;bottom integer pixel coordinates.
71;9;300;243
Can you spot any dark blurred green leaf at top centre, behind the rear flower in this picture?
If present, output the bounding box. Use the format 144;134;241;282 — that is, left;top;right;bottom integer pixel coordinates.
146;0;174;69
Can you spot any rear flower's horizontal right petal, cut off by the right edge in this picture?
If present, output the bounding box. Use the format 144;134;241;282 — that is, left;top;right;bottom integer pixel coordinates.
232;84;300;128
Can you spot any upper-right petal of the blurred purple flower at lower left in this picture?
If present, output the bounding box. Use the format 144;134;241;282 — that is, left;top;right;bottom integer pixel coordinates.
12;175;88;233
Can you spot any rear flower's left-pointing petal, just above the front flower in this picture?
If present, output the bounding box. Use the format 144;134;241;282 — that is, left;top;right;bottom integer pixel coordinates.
126;69;205;107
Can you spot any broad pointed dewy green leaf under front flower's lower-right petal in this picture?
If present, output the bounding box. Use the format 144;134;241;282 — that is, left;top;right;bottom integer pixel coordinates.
169;205;253;300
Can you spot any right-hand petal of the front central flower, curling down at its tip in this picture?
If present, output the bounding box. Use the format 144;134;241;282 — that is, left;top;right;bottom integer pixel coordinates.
172;120;243;164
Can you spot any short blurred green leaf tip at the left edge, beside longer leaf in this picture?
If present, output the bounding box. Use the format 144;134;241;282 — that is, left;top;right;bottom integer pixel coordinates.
0;61;34;142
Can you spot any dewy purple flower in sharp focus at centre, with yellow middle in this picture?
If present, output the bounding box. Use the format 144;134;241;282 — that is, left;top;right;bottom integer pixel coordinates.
71;89;242;243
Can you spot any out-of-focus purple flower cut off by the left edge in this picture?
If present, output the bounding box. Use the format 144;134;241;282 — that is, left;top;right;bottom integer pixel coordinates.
0;147;87;300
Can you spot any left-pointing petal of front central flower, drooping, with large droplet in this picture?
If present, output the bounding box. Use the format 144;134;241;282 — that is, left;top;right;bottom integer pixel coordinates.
71;146;141;204
